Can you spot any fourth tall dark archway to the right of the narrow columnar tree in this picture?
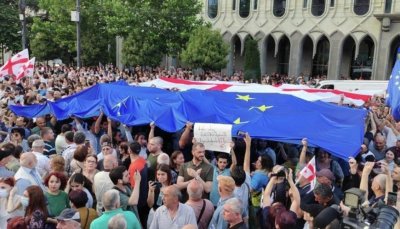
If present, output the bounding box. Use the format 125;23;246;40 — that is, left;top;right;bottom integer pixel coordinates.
313;37;330;76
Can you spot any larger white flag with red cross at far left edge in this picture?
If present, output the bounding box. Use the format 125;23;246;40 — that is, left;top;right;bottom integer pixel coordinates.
0;49;29;78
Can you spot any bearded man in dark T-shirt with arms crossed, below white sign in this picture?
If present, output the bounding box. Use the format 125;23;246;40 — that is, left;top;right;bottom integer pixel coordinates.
177;142;214;202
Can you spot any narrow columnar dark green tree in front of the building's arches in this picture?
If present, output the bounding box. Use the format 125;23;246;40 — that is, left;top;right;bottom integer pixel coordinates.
244;38;261;82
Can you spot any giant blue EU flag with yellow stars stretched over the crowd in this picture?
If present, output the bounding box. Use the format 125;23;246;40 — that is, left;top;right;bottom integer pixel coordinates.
10;83;367;158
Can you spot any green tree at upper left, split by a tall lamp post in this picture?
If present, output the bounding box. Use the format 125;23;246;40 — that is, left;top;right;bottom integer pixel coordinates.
31;0;115;65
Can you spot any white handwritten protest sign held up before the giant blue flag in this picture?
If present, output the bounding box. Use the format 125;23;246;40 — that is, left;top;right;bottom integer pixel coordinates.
194;123;232;153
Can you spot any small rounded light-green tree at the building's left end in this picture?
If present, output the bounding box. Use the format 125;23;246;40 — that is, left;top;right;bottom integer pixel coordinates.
181;26;229;70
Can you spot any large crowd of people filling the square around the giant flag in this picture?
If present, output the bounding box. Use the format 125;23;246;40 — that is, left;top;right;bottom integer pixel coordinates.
0;66;400;229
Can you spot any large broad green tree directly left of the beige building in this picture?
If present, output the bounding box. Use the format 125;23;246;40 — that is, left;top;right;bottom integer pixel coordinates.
106;0;203;66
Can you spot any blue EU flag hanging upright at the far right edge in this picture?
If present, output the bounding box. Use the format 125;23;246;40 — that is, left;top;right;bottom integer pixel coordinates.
386;47;400;121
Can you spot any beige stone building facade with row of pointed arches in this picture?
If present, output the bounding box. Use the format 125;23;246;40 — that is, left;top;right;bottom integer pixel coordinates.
202;0;400;80
